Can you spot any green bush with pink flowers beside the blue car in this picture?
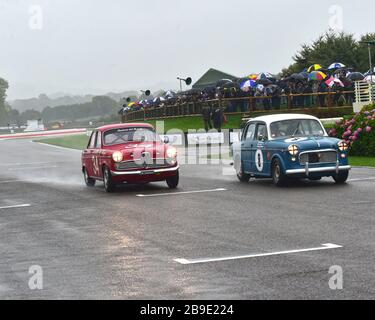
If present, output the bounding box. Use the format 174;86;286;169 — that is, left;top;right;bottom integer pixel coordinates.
329;104;375;156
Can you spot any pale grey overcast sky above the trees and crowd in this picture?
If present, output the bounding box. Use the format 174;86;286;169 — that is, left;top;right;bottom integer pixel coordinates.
0;0;375;99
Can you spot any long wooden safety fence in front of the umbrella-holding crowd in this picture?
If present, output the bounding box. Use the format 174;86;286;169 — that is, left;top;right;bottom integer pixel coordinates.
122;91;355;122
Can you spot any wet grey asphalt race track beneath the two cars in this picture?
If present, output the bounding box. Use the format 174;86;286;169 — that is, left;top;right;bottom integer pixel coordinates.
0;140;375;299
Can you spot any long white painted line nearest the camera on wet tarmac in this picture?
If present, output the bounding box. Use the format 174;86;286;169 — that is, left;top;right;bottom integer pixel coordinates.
174;243;342;264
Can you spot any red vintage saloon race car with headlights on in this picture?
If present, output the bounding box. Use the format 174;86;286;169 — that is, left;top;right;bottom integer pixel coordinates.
82;123;179;192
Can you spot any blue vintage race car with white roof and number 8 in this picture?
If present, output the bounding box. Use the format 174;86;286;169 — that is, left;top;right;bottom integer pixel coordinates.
232;114;351;186
